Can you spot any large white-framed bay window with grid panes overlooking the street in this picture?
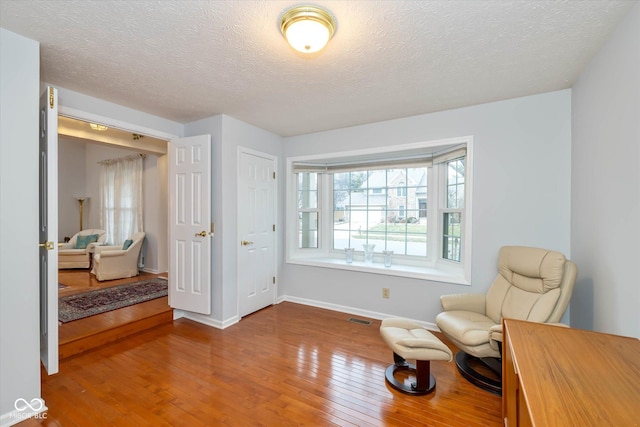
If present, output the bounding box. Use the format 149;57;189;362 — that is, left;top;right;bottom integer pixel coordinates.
287;137;472;283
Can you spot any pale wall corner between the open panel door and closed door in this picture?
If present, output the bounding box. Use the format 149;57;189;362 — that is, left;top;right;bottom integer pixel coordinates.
185;115;284;326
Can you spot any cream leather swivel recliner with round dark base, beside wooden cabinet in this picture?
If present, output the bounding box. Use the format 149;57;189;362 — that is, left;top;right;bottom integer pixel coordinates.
436;246;578;394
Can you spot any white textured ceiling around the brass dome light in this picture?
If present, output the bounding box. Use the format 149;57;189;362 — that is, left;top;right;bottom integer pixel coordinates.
0;0;635;136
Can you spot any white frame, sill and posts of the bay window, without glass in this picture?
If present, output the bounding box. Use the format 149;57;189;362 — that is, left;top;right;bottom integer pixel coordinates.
286;136;473;285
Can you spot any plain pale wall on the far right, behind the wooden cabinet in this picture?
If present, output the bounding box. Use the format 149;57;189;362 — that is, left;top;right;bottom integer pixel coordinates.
571;4;640;337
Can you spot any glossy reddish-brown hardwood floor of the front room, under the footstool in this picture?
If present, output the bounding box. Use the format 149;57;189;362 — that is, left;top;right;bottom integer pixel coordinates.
20;302;502;427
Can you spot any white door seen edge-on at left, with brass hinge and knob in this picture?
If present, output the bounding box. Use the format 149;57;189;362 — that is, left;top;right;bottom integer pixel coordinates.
39;87;58;375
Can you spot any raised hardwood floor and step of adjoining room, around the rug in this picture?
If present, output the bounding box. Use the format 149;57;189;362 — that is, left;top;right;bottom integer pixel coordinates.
58;270;173;359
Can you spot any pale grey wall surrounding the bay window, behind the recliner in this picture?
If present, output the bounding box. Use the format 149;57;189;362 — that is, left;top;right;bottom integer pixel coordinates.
280;90;571;323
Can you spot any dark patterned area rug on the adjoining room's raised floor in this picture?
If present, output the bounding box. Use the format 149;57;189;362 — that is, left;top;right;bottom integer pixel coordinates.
58;277;168;323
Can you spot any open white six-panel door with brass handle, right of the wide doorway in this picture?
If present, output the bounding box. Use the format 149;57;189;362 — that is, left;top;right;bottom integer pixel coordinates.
169;135;212;314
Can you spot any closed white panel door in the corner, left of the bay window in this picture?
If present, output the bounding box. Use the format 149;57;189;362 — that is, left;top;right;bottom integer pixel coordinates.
238;151;276;316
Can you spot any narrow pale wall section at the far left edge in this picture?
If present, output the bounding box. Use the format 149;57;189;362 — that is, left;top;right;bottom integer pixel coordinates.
0;28;40;425
